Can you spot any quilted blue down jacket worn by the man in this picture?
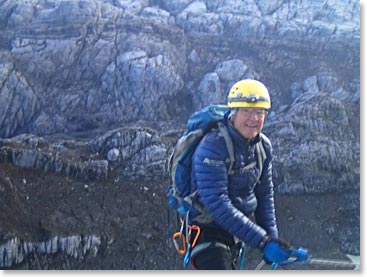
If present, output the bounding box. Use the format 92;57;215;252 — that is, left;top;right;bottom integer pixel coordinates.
191;115;278;248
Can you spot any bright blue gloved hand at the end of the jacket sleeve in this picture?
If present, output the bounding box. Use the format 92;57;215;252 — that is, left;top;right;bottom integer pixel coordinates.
263;238;292;264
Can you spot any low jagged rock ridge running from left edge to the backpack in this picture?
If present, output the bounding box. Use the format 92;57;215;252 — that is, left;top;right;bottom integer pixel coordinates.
0;127;169;180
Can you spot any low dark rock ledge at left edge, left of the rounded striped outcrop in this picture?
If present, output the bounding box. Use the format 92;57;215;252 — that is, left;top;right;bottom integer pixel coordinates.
0;135;108;180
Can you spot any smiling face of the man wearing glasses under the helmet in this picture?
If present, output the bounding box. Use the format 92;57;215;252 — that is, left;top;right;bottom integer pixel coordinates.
232;108;267;139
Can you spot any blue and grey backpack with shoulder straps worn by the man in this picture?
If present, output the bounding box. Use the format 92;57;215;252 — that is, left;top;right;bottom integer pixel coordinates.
167;104;266;223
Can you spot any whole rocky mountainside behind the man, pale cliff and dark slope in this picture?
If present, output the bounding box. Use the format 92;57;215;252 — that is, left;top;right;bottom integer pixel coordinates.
0;0;360;269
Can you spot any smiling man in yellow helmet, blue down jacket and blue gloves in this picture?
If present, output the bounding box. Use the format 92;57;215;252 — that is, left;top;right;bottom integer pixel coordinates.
190;80;302;269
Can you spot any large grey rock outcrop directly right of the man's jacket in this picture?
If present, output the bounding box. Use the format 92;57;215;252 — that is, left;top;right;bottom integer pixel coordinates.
266;73;360;194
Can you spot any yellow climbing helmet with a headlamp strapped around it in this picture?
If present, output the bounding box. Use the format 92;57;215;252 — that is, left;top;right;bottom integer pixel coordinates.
227;79;271;109
